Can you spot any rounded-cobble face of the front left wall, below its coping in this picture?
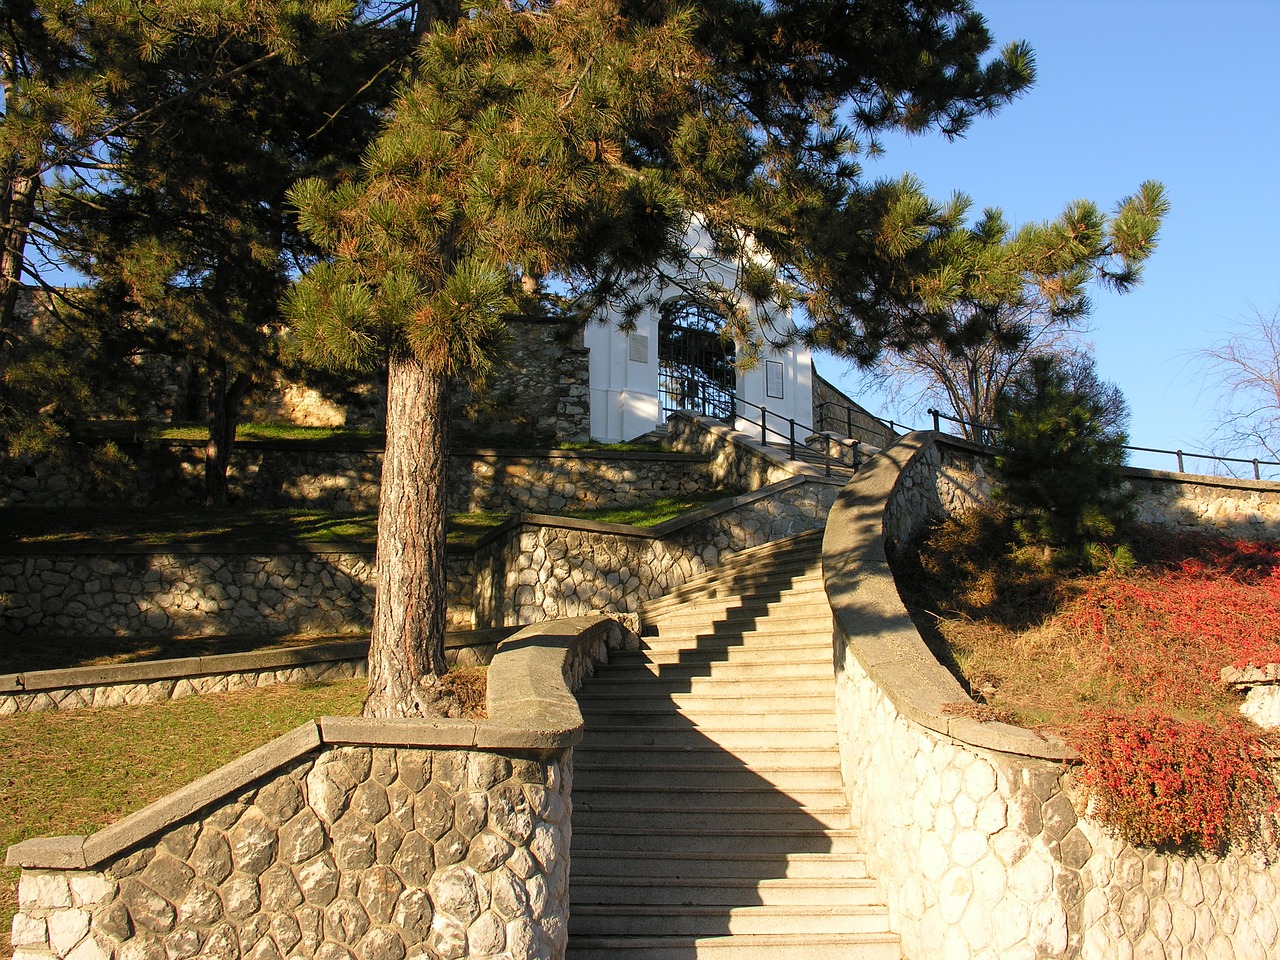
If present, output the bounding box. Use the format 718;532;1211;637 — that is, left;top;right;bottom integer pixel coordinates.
13;746;571;960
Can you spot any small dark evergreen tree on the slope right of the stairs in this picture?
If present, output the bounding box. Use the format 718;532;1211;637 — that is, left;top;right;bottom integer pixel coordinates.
996;355;1130;564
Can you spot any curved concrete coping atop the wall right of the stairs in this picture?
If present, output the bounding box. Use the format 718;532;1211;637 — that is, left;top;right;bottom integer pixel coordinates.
822;431;1076;760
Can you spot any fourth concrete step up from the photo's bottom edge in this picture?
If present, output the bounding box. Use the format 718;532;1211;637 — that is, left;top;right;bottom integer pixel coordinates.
573;850;869;881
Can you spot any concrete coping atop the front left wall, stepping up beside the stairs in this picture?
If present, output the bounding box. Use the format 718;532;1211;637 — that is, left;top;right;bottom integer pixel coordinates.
5;616;617;870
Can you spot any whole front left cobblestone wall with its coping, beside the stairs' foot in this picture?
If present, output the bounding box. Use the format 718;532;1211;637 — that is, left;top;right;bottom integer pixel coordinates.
6;620;634;960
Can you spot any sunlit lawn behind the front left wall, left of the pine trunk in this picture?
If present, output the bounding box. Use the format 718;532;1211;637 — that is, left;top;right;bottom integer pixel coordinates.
0;680;366;956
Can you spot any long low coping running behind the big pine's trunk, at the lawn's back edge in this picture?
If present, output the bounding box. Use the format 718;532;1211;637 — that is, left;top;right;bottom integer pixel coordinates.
0;627;516;694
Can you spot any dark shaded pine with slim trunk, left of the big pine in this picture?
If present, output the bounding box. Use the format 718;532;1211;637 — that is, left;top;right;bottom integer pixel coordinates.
55;3;410;504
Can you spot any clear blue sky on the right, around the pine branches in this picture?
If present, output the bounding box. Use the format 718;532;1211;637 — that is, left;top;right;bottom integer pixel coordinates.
817;0;1280;472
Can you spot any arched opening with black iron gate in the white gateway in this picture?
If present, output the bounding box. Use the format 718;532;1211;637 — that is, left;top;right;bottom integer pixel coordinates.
658;298;737;424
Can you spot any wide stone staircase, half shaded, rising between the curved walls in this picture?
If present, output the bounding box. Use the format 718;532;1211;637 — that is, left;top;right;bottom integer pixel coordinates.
567;532;901;960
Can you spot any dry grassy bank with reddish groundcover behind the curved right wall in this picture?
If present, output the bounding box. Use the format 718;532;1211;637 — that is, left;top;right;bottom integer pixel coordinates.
896;520;1280;731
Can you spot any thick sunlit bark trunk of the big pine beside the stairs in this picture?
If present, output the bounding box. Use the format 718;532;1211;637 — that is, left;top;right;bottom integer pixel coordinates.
364;358;449;717
